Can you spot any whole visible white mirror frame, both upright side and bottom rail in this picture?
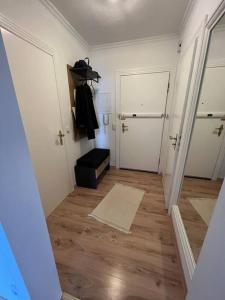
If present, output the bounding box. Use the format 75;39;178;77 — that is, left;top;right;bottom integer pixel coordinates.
169;0;225;289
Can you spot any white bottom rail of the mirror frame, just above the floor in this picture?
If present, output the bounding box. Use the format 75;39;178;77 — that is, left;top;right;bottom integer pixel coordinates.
171;205;196;289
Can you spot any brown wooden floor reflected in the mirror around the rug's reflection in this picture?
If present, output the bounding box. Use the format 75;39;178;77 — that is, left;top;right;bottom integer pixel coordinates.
179;177;222;262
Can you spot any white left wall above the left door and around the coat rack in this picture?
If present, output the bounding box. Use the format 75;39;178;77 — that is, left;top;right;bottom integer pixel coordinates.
0;0;92;188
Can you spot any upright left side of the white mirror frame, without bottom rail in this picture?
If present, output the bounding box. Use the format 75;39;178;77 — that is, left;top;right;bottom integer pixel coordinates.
169;0;225;213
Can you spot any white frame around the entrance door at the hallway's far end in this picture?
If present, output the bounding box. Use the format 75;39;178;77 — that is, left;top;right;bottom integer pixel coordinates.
115;66;176;173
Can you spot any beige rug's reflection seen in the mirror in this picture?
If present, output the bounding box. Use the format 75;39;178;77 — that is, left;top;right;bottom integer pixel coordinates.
188;198;216;225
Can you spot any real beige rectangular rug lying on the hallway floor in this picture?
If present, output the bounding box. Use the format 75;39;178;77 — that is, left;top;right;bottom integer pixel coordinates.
89;184;145;233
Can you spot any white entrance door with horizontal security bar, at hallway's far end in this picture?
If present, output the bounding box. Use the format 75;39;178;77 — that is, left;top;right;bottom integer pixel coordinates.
120;72;170;172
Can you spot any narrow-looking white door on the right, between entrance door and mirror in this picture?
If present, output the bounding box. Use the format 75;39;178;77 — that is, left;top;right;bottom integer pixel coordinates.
163;41;197;205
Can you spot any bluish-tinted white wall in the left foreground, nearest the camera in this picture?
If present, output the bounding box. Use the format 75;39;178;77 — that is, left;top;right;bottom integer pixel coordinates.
0;31;61;300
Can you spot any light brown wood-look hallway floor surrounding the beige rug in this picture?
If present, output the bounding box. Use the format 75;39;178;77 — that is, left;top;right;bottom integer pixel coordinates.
48;169;185;300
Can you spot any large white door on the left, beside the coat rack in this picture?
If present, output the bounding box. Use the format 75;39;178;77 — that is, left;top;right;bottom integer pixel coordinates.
2;30;71;215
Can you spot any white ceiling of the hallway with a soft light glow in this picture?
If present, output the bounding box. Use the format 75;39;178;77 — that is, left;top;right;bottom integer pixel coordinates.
51;0;189;45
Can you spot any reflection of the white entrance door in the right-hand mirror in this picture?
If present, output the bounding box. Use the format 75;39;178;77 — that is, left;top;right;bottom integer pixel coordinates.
185;66;225;178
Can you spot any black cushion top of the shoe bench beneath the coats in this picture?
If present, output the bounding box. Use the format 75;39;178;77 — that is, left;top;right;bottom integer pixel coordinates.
77;148;110;169
